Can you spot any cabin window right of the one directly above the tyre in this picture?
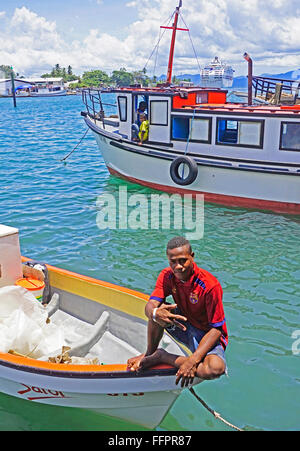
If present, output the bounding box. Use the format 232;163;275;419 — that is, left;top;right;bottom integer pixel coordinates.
216;118;264;148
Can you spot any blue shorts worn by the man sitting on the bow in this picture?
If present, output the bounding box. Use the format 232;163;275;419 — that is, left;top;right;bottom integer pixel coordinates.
166;318;227;368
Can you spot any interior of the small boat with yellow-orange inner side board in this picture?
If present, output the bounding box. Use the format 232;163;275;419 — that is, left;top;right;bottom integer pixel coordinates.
4;265;187;370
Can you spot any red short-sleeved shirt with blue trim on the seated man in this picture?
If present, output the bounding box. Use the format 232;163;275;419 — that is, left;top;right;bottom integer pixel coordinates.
150;263;228;349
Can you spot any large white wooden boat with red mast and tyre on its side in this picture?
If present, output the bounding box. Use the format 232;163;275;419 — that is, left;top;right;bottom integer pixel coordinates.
82;3;300;214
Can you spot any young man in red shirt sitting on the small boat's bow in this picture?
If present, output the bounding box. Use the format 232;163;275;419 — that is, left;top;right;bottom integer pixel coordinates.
128;237;228;386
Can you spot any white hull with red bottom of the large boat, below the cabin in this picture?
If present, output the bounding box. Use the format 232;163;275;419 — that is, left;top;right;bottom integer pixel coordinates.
94;125;300;213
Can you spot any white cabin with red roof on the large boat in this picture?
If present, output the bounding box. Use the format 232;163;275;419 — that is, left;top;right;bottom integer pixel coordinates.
110;87;300;161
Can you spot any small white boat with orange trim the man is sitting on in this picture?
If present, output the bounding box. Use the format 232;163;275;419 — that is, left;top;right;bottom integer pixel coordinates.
0;225;200;428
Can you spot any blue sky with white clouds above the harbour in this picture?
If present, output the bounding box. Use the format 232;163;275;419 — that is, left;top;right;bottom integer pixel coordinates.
0;0;300;75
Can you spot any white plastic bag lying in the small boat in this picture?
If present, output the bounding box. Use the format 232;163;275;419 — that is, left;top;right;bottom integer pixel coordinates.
0;286;65;359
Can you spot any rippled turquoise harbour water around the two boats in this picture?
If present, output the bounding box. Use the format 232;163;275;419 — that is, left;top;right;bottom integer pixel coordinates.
0;96;300;431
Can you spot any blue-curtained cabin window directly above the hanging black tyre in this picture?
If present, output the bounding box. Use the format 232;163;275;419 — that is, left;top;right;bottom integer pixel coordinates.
172;116;211;143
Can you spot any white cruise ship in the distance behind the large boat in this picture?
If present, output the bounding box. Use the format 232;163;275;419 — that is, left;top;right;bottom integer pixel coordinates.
200;56;234;88
